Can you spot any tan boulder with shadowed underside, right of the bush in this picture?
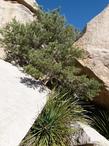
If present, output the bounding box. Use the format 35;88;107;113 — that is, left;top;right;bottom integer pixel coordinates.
74;5;109;107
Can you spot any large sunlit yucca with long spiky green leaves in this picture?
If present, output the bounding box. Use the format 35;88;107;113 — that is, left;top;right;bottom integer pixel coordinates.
22;94;83;146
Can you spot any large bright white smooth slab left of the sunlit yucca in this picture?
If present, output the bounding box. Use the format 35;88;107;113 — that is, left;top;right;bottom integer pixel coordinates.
0;60;48;146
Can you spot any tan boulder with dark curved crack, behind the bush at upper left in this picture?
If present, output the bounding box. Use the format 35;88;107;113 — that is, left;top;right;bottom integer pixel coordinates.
0;0;37;58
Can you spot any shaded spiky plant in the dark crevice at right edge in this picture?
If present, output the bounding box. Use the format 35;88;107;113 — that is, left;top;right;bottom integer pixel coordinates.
87;104;109;139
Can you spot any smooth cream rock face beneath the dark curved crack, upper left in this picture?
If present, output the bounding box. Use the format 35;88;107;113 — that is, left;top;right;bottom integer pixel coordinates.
0;0;36;27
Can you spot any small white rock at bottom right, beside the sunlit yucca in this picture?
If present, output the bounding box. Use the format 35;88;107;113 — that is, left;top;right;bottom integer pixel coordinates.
73;122;109;146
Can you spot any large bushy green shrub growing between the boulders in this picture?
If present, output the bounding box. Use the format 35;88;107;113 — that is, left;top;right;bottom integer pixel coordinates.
1;10;100;99
